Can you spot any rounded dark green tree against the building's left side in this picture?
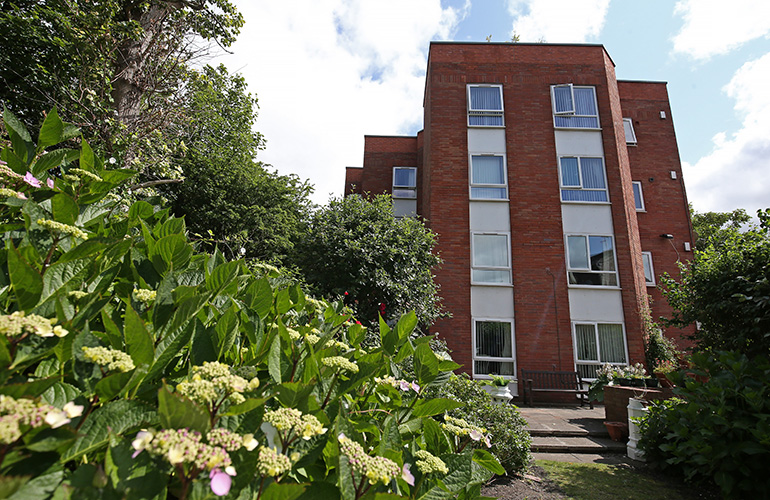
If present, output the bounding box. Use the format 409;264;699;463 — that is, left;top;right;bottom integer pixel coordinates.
294;195;441;325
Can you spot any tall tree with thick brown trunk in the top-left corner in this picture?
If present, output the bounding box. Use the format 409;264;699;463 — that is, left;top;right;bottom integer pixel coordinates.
0;0;243;166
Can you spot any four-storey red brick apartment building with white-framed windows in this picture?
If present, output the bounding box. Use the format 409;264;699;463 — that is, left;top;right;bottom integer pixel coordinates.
346;42;693;390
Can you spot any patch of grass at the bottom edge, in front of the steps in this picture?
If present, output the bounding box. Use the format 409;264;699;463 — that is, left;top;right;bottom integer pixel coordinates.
535;460;699;500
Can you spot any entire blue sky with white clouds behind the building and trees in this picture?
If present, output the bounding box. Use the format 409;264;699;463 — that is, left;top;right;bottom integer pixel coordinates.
212;0;770;215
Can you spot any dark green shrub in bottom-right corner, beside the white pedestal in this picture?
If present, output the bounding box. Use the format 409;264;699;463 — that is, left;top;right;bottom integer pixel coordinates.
640;351;770;498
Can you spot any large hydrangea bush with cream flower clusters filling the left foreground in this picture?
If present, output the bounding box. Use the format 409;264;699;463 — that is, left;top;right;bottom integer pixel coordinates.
0;112;504;500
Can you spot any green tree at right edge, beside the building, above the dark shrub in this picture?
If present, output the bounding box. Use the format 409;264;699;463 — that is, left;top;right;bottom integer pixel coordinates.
662;210;770;357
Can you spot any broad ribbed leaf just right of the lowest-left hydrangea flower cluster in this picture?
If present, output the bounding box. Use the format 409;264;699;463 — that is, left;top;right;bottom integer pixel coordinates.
61;399;158;462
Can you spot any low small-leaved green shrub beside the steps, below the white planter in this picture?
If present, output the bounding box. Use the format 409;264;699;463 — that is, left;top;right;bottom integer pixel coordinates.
424;374;532;472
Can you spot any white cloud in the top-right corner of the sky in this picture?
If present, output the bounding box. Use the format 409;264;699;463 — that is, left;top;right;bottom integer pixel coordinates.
673;0;770;59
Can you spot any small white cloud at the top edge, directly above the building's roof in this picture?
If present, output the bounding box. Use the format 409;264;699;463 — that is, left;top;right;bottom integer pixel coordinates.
508;0;610;43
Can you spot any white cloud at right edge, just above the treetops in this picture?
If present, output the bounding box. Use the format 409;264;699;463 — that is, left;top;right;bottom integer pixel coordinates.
683;54;770;215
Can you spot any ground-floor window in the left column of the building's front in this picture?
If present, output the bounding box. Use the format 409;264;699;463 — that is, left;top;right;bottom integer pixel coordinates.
473;320;516;377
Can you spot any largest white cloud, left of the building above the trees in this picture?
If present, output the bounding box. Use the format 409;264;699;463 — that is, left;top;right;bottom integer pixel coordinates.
212;0;470;203
